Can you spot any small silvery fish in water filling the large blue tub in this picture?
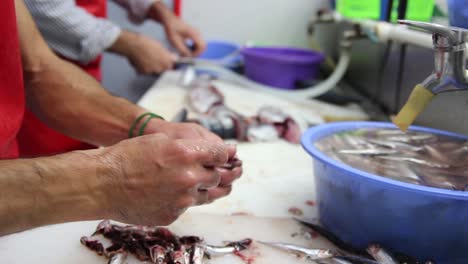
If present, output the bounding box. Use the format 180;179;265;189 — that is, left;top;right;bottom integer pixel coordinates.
316;128;468;191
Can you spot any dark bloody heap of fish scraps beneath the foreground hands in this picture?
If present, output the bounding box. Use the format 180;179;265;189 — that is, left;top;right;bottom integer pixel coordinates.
80;220;252;264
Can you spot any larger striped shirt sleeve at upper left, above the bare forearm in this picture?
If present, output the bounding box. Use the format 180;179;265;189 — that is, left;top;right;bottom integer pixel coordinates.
24;0;121;64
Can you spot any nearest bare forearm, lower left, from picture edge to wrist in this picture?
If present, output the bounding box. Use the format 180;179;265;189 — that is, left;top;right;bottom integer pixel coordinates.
0;147;111;236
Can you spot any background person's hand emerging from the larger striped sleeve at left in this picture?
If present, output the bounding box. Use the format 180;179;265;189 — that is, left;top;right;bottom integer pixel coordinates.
109;30;177;74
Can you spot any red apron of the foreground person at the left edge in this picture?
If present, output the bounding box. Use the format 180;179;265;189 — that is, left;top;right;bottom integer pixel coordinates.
0;0;24;159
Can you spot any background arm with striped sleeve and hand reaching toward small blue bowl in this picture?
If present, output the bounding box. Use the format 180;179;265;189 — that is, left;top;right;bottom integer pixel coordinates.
114;0;206;56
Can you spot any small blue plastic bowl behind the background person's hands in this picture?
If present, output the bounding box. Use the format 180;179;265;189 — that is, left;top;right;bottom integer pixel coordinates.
199;40;242;68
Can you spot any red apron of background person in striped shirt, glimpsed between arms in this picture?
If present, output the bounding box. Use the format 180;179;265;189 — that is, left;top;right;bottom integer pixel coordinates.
17;0;106;157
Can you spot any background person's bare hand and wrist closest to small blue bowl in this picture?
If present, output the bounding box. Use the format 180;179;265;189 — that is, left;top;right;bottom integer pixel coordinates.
148;1;206;57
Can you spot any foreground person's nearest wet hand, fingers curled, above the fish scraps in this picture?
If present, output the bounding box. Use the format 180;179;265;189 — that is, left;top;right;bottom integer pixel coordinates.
102;134;242;225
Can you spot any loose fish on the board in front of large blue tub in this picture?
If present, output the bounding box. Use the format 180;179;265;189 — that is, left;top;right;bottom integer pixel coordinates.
258;218;433;264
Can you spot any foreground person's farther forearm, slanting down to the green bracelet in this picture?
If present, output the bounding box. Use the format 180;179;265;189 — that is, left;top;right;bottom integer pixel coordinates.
16;0;145;145
